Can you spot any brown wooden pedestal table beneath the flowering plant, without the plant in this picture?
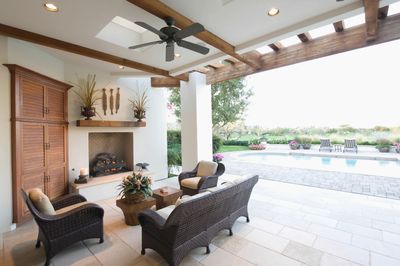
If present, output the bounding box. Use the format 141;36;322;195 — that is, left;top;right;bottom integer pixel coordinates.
117;197;156;225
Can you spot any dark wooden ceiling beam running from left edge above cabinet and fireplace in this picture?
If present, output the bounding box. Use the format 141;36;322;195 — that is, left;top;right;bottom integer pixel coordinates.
0;24;177;77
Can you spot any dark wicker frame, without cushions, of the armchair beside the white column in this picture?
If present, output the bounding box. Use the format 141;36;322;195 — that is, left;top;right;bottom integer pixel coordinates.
178;163;225;195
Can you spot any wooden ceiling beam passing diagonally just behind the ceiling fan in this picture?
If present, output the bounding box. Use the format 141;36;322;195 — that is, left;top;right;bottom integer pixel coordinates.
127;0;259;68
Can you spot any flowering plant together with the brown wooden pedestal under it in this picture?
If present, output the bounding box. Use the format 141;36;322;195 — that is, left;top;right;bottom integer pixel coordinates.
117;172;156;225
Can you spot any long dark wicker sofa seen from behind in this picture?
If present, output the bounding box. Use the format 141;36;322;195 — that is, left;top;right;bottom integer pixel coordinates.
139;176;258;266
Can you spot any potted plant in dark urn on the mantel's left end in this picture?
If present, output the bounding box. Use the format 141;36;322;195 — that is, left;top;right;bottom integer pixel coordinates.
71;74;101;120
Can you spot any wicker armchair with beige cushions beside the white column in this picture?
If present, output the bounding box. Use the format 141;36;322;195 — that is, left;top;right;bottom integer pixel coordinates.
178;161;225;195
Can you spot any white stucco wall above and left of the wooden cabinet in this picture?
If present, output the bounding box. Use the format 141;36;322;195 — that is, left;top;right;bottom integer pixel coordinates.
0;36;64;247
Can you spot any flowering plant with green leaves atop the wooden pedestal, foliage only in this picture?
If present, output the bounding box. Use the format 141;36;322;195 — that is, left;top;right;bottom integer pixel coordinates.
118;172;153;201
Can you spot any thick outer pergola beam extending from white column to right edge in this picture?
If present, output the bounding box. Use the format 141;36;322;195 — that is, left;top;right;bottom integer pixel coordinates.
207;14;400;84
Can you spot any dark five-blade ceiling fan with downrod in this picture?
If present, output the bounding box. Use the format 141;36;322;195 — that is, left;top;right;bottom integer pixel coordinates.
129;17;210;62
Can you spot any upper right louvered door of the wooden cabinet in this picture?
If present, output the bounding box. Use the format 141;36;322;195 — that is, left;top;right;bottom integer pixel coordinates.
47;87;67;121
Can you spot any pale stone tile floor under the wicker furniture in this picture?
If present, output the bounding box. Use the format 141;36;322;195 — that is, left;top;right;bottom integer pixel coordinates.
0;179;400;266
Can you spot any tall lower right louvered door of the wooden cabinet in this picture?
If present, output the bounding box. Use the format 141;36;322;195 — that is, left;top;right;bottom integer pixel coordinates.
46;124;68;199
